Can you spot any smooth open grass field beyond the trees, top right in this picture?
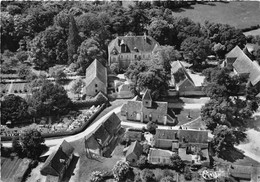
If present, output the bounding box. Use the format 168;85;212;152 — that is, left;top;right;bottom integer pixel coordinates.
174;1;260;28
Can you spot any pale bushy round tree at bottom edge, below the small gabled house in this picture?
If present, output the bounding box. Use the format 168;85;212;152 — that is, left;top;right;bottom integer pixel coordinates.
112;161;130;181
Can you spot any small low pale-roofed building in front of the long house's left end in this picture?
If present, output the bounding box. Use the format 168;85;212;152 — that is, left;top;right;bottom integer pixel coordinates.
147;148;174;164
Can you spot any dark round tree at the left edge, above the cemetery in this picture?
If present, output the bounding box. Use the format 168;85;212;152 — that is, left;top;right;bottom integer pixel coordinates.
1;94;28;125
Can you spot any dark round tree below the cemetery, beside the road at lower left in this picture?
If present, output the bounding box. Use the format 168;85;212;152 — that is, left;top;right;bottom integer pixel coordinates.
19;129;46;159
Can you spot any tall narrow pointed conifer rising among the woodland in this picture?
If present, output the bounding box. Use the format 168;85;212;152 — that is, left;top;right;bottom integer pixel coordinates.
67;15;81;63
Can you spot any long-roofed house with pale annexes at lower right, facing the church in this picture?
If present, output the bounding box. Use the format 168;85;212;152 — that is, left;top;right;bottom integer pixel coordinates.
153;128;209;165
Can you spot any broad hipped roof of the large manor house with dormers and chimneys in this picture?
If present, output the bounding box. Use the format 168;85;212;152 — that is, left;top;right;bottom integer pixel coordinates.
108;35;159;53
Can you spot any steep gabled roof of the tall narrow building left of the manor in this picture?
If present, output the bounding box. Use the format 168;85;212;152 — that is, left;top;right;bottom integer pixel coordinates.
85;59;107;87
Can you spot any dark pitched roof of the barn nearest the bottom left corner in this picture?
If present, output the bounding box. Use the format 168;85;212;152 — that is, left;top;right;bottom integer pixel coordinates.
41;140;74;176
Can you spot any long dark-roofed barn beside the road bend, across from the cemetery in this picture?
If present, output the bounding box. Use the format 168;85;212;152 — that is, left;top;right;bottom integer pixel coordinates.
85;113;121;156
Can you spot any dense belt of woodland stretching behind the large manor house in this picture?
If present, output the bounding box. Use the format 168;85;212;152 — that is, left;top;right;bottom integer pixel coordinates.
1;1;246;74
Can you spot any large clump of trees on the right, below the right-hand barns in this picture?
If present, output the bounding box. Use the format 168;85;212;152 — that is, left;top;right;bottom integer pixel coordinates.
201;68;259;160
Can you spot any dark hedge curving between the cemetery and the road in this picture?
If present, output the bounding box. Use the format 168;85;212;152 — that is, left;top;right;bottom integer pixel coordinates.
1;104;106;141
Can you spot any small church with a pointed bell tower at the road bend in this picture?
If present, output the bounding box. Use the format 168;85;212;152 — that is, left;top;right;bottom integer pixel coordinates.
121;90;176;125
